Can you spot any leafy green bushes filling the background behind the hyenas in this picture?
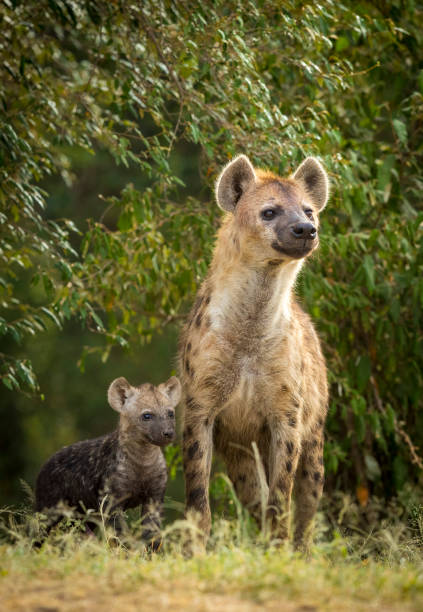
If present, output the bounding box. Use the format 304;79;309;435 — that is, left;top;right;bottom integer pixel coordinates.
0;0;423;503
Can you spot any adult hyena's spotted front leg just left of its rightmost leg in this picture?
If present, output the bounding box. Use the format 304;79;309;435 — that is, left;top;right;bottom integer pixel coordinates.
267;415;300;540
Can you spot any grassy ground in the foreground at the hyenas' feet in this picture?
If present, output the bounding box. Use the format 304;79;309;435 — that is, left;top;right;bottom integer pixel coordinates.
0;504;423;612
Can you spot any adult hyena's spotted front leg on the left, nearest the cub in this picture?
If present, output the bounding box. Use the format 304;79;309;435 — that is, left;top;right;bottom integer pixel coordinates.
183;398;213;537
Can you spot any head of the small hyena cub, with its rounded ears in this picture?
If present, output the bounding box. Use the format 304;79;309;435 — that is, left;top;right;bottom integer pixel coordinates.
108;376;181;446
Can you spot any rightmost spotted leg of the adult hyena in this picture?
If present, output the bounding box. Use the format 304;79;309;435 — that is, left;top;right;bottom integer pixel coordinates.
294;431;324;552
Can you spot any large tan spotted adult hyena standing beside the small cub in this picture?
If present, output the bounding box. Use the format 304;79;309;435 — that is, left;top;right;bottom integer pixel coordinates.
180;155;328;547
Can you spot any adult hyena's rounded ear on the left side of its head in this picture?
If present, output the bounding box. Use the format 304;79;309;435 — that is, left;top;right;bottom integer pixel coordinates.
216;155;256;212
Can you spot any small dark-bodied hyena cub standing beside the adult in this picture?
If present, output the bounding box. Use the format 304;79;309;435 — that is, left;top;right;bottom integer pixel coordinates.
35;376;181;540
